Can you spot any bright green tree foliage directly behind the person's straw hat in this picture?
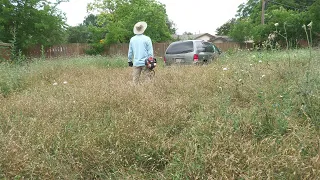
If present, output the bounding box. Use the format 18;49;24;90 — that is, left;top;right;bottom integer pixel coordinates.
88;0;175;44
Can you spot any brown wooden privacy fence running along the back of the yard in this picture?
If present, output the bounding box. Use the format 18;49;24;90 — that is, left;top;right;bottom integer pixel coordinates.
27;42;252;58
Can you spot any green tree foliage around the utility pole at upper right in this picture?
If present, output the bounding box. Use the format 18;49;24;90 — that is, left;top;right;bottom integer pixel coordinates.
224;0;320;43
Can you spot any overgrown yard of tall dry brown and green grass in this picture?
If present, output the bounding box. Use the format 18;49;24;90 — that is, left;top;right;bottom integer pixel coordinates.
0;50;320;179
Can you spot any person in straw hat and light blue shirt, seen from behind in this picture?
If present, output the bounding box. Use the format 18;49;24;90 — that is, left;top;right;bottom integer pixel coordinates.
128;22;153;84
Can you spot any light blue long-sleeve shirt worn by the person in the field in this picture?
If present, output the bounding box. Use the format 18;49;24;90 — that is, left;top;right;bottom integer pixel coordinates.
128;34;153;66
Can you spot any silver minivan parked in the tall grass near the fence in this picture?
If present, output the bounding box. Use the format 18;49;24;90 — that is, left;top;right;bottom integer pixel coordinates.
164;40;214;66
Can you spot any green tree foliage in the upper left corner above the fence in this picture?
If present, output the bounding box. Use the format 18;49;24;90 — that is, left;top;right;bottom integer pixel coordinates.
0;0;66;50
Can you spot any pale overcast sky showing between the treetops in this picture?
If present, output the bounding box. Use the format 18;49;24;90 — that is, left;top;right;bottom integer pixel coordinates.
59;0;247;34
